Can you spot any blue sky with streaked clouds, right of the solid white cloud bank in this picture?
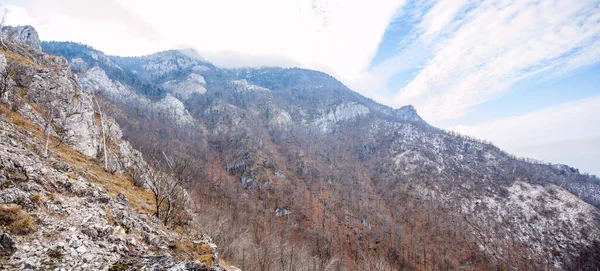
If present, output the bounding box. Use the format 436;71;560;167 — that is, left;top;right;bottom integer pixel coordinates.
360;0;600;174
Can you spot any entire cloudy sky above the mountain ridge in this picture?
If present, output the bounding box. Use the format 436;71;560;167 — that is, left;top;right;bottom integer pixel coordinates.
0;0;600;175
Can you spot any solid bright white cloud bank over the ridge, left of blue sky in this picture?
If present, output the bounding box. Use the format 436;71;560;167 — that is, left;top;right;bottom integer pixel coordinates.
1;0;405;83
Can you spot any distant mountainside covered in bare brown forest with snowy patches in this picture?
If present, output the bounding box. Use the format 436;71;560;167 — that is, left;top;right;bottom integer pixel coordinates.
42;39;600;270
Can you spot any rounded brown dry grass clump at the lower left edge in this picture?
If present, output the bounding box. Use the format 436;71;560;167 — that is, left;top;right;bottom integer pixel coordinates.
0;204;36;234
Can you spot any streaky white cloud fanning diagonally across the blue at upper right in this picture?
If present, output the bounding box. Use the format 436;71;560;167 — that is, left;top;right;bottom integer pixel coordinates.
390;0;600;121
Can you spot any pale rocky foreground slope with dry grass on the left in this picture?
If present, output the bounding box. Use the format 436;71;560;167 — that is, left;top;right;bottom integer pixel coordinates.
0;27;231;270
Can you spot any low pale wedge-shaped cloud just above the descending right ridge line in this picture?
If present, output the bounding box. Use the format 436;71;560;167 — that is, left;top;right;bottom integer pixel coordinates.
450;96;600;175
